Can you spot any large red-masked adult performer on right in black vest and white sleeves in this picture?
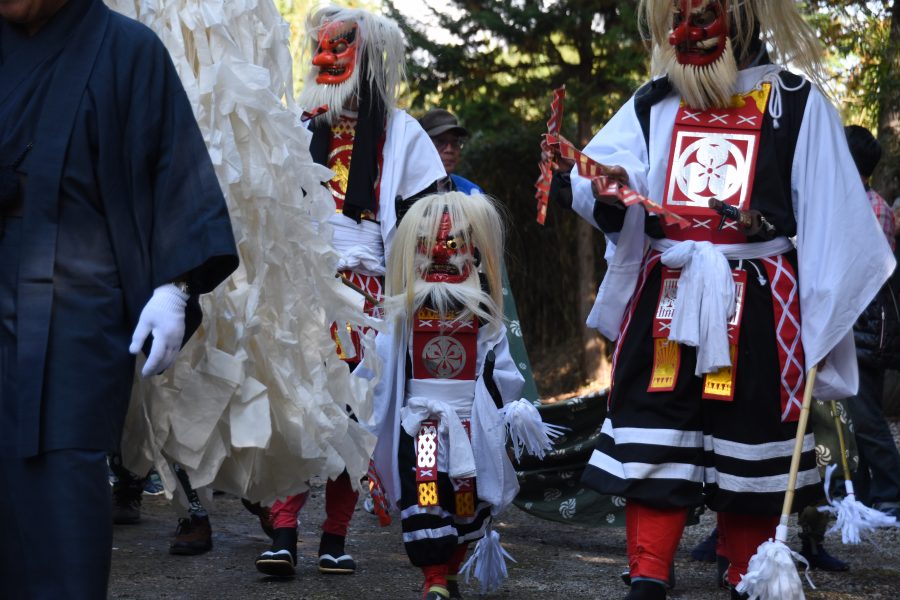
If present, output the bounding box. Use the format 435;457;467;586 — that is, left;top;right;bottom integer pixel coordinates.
544;0;894;600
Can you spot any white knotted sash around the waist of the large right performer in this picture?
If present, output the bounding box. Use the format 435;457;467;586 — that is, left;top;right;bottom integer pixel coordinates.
650;237;794;377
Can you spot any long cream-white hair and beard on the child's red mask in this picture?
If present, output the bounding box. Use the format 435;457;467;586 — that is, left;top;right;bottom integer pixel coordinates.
385;192;505;336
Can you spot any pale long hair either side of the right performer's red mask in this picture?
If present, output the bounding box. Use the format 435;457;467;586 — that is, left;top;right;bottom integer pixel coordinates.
638;0;825;89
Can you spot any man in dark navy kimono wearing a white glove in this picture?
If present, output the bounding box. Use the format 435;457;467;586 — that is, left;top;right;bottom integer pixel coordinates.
0;0;237;599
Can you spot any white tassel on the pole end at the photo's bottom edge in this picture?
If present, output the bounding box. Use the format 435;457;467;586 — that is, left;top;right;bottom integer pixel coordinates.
737;524;816;600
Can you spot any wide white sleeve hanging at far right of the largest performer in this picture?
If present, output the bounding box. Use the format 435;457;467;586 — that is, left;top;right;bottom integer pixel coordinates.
791;88;895;400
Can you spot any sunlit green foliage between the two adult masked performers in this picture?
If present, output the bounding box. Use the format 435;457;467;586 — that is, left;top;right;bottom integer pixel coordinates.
385;0;646;135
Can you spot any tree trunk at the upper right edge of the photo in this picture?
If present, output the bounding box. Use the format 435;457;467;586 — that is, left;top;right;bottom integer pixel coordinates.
873;0;900;203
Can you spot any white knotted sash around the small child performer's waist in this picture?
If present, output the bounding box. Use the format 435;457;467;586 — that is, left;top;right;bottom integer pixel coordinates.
400;379;475;478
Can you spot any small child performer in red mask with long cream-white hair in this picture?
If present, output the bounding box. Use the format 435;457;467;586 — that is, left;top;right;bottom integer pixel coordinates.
374;192;552;600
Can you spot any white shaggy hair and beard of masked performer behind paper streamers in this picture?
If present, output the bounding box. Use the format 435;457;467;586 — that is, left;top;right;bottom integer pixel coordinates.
300;5;406;123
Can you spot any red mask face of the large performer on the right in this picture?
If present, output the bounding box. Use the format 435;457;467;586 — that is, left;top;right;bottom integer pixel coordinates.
669;0;728;66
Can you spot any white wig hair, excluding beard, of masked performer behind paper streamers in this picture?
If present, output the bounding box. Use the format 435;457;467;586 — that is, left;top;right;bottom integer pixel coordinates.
306;5;406;111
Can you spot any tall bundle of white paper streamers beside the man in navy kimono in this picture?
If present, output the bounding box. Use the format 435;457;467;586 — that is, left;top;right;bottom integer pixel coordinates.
107;0;374;502
